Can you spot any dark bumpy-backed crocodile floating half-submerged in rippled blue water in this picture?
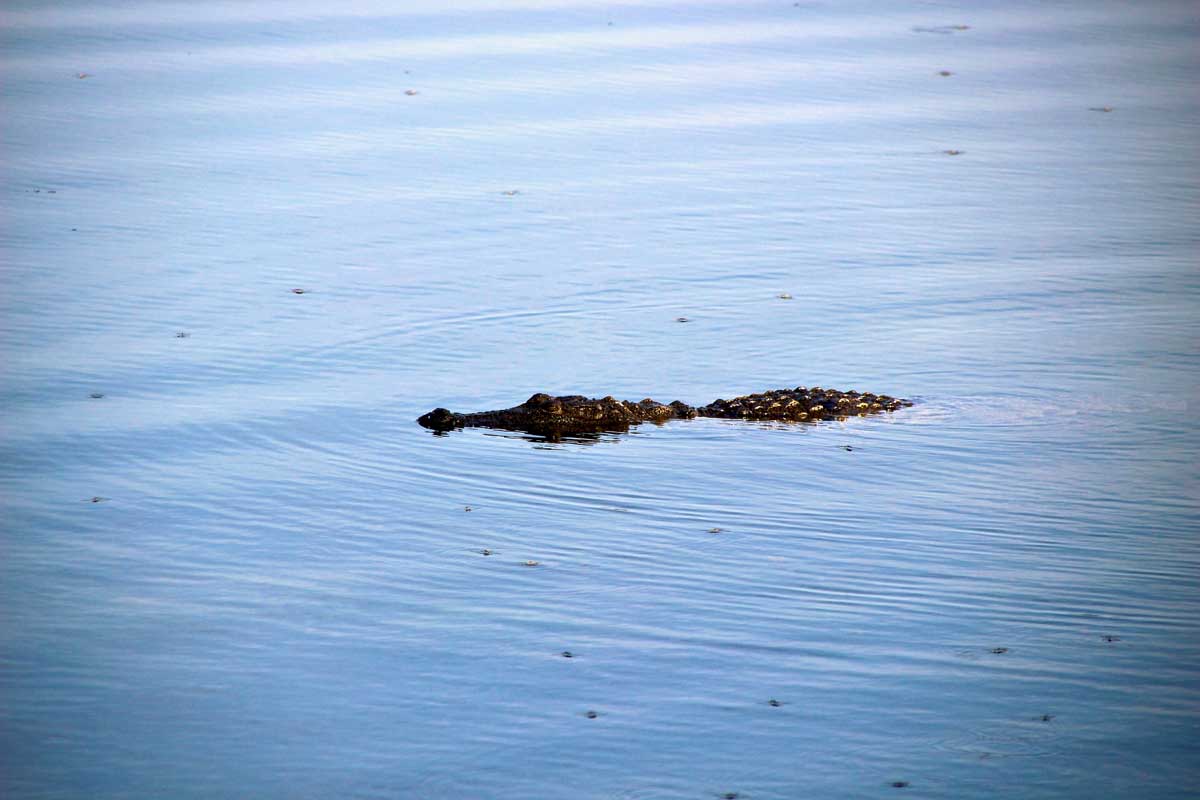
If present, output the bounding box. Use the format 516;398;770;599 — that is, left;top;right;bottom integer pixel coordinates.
416;386;912;438
